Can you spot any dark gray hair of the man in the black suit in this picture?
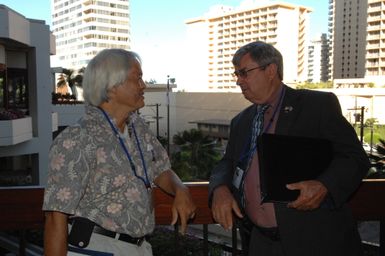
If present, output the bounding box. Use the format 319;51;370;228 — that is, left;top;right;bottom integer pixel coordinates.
232;41;283;81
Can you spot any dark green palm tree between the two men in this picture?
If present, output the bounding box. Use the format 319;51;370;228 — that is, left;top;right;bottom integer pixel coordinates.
171;129;221;180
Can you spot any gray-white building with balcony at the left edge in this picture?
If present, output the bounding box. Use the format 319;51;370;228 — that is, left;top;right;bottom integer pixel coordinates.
0;5;57;185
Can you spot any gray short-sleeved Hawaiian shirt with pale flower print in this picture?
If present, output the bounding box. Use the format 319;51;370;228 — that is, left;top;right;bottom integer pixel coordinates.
43;106;171;237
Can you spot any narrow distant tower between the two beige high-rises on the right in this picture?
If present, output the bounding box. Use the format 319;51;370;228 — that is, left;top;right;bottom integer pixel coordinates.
307;34;329;83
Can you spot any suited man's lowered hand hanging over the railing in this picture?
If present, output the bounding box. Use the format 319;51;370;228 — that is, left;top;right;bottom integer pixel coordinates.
211;185;243;230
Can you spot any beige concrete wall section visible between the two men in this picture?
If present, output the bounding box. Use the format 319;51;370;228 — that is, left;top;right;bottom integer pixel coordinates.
140;92;246;139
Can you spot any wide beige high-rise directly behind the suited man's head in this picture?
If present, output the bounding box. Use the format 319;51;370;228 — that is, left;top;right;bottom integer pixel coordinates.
185;1;311;92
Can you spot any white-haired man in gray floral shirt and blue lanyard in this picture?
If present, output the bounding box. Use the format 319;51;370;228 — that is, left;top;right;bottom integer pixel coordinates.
43;49;195;256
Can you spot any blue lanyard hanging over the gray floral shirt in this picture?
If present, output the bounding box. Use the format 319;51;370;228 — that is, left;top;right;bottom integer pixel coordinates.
98;107;151;189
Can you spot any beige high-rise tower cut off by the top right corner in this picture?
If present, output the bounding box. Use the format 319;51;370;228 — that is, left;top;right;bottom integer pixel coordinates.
329;0;385;87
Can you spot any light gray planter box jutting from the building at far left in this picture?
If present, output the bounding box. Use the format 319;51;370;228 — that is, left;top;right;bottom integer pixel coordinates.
0;117;32;146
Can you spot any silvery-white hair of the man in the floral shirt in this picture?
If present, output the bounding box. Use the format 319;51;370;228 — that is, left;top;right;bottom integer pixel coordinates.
83;49;141;106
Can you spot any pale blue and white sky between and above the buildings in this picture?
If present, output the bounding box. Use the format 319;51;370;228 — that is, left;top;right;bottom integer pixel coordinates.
0;0;329;83
